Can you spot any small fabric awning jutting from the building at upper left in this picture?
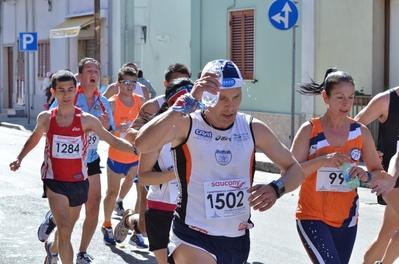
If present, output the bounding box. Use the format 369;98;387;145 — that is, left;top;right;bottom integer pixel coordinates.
50;15;94;38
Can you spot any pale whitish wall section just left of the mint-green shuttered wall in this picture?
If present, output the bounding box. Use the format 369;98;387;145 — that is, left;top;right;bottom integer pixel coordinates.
135;0;192;94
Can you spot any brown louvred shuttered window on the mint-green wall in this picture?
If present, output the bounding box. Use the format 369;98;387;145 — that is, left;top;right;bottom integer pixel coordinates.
229;9;255;79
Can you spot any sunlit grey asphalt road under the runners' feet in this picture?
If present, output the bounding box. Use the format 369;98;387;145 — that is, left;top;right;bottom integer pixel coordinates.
0;127;399;264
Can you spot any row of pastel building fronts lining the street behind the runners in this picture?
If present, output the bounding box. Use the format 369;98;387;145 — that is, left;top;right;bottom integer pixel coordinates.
0;0;399;146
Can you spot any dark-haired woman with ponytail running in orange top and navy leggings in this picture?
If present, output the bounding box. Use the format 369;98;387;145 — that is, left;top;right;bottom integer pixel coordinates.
291;68;393;264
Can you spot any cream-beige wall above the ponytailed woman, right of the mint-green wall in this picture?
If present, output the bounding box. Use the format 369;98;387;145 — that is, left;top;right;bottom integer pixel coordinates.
315;0;384;115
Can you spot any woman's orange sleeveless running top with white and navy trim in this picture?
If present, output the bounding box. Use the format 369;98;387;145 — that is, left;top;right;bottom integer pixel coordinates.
296;118;363;227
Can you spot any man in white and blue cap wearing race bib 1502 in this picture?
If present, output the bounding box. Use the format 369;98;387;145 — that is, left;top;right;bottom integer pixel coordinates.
135;60;304;264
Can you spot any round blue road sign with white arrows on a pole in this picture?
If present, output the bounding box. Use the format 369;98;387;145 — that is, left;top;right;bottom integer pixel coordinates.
269;0;298;30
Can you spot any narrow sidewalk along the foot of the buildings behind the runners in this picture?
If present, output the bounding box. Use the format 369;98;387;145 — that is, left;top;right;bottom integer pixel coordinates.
0;117;280;173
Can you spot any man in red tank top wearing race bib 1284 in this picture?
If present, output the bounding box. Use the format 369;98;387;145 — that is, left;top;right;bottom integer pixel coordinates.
10;70;139;263
